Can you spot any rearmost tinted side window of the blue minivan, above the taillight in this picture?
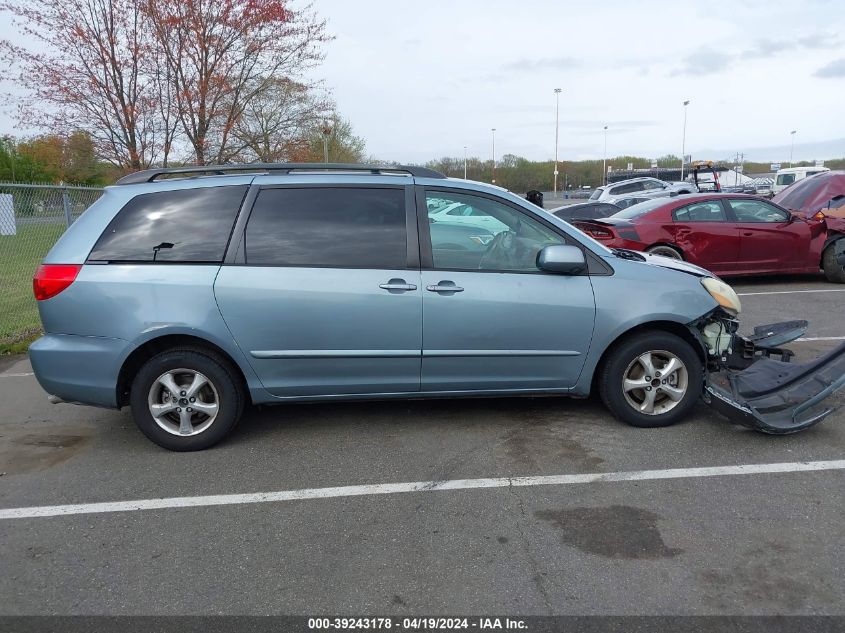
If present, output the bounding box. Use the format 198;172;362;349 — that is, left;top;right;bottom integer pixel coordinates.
88;186;247;264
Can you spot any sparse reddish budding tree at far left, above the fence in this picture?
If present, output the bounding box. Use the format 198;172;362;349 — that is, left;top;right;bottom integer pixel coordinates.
0;0;162;169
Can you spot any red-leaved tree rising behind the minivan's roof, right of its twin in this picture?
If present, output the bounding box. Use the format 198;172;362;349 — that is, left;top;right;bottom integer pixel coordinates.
144;0;329;165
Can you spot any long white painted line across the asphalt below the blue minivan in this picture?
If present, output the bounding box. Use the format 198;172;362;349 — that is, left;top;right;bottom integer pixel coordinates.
0;459;845;520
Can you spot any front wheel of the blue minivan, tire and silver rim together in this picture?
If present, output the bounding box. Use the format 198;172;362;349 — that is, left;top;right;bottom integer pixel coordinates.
599;332;703;428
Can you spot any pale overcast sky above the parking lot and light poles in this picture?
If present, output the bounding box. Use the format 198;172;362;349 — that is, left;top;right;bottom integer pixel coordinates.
0;0;845;162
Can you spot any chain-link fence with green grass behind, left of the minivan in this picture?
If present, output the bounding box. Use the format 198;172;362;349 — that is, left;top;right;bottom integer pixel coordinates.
0;183;103;351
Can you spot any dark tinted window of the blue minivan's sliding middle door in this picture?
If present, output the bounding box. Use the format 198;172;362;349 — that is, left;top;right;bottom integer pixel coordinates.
244;187;407;269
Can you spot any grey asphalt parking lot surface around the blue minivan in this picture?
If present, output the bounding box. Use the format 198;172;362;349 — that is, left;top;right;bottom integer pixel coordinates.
0;276;845;615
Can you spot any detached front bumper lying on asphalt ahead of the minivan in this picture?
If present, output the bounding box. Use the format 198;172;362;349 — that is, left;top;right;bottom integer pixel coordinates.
704;321;845;435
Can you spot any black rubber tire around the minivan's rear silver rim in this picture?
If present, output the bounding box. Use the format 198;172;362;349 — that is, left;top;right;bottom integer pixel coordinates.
129;348;246;451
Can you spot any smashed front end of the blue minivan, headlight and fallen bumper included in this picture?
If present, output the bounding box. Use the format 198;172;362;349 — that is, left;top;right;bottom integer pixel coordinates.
688;277;845;435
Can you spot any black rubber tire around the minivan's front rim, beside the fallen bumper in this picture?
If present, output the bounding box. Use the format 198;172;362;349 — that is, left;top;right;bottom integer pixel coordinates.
598;331;704;428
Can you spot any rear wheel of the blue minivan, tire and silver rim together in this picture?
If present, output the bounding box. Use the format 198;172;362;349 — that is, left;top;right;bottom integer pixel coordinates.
129;349;244;451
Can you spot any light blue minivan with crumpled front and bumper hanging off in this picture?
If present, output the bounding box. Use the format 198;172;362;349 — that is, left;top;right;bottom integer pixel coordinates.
30;164;845;450
